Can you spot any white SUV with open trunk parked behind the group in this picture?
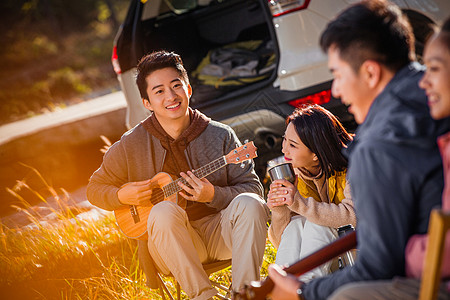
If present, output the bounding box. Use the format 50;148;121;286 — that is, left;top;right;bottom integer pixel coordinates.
112;0;450;174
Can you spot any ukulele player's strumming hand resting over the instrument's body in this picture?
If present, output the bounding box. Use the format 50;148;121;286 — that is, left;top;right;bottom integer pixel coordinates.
117;179;152;205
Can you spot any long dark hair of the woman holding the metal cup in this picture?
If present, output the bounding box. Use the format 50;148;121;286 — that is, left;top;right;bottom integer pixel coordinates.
286;104;353;179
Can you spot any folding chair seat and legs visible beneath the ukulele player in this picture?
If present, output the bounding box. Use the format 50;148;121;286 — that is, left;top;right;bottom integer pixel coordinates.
157;259;232;300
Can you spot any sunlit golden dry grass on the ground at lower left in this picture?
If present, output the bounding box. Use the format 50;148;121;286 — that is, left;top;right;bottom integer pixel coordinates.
0;165;274;300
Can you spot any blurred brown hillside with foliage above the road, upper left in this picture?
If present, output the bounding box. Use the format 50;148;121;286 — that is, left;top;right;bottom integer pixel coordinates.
0;0;129;125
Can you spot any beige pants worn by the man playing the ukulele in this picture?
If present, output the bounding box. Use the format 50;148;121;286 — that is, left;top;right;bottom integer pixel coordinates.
148;193;268;299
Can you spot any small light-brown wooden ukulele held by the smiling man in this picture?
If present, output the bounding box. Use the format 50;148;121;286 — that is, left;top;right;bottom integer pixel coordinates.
114;142;258;240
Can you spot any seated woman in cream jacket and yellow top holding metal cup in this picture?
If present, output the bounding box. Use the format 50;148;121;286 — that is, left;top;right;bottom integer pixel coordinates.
267;105;356;281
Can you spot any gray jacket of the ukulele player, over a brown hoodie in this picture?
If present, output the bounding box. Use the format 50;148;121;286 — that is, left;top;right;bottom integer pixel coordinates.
87;117;263;210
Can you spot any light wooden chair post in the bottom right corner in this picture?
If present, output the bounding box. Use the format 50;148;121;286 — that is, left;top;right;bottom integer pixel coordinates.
419;209;450;300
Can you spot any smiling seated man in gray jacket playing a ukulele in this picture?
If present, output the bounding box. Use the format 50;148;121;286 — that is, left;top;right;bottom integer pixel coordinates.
87;51;268;299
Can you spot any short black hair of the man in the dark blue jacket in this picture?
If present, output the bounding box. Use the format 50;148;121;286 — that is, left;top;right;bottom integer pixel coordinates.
320;0;415;72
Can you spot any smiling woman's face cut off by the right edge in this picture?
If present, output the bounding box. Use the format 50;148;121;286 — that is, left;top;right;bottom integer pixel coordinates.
419;33;450;120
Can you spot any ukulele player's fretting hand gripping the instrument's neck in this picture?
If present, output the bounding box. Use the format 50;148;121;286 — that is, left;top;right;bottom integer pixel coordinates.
178;171;214;202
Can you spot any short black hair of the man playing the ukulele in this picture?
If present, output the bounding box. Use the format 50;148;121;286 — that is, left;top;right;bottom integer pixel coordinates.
136;50;189;100
